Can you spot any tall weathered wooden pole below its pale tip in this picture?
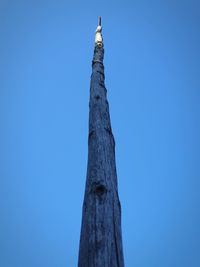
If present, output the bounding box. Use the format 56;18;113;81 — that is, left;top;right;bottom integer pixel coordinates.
78;46;124;267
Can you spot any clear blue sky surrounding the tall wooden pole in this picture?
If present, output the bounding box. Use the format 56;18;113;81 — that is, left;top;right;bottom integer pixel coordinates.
0;0;200;267
